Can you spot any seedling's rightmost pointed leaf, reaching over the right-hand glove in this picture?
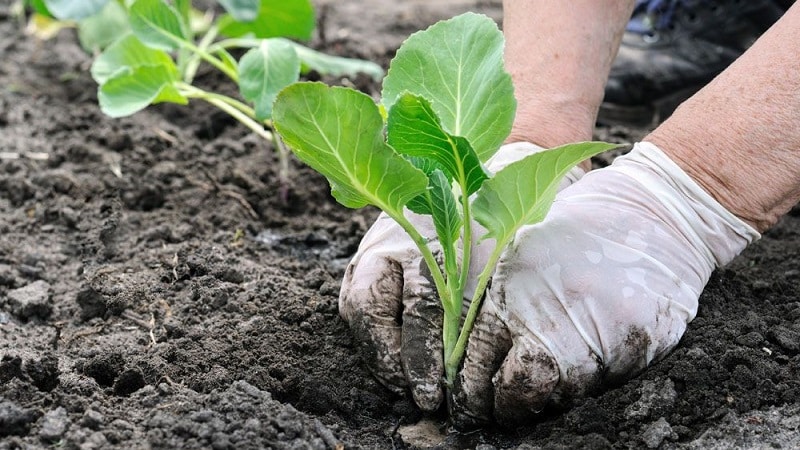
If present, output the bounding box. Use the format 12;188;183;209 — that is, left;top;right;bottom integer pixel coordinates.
472;142;619;245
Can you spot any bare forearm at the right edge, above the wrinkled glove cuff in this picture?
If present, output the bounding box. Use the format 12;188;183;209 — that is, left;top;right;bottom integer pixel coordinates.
645;6;800;231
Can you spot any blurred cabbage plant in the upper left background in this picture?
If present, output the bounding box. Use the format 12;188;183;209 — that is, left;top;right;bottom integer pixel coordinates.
26;0;383;195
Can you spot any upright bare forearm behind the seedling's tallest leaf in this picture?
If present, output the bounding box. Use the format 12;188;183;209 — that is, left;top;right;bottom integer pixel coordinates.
503;0;633;152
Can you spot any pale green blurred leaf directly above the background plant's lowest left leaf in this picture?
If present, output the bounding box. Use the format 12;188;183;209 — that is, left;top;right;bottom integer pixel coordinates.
91;34;179;85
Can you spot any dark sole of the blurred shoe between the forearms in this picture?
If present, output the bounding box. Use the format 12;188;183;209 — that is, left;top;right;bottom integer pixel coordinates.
597;87;699;128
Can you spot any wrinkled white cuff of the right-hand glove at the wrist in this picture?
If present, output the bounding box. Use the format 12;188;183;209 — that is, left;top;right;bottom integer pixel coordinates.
613;142;761;267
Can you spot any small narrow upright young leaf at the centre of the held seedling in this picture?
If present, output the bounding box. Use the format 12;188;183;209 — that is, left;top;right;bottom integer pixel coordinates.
427;170;462;267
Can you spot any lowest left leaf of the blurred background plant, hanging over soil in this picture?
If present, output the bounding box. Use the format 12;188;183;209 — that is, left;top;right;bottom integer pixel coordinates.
97;66;188;117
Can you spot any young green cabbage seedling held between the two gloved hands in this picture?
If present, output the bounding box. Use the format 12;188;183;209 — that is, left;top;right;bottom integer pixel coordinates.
273;13;615;388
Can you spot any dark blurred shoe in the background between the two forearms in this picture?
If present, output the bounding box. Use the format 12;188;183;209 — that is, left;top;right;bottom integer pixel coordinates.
597;0;792;126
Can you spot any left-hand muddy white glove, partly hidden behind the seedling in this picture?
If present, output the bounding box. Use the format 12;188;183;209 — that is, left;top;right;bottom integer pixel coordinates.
339;142;583;411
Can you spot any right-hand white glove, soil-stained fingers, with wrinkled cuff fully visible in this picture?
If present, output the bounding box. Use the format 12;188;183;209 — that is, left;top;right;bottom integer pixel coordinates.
453;142;759;426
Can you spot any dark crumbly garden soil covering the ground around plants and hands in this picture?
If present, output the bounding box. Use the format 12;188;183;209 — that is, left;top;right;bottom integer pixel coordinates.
0;0;800;450
